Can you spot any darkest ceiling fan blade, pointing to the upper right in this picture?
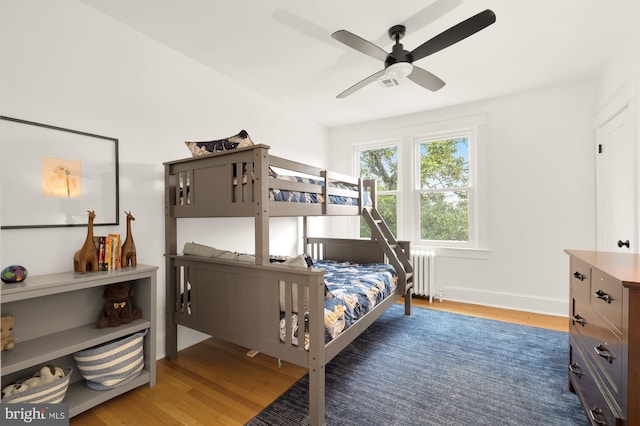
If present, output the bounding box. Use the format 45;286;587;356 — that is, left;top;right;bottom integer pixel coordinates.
411;9;496;61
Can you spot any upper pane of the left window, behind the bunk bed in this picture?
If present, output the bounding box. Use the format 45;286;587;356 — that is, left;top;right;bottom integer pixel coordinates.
360;146;398;191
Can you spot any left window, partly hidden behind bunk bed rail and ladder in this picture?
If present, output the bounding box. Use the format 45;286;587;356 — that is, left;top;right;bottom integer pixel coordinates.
358;145;398;237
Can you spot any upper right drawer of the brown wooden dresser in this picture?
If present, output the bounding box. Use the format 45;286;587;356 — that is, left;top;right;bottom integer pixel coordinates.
591;269;623;332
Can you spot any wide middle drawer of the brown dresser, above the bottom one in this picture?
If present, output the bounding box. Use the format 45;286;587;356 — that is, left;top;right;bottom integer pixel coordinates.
571;299;623;401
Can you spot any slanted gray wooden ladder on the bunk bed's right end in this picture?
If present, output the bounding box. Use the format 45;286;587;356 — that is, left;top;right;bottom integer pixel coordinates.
362;207;413;315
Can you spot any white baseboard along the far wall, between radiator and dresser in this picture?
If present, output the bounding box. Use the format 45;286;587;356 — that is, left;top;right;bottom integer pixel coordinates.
442;287;569;317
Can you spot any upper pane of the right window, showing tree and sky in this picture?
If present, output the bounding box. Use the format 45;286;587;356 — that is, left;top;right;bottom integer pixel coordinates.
420;137;469;189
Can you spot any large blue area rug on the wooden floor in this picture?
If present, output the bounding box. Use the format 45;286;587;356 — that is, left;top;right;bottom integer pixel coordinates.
247;305;588;426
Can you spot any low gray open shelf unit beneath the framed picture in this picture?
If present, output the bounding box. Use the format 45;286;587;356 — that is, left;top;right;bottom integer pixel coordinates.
0;265;158;417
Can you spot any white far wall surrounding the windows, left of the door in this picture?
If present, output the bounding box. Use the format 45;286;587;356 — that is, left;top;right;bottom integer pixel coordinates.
330;82;596;316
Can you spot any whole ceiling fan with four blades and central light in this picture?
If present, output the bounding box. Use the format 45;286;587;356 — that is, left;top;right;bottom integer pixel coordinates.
331;9;496;98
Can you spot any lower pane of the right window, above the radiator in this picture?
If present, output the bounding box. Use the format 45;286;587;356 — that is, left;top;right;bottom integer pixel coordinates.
420;191;469;241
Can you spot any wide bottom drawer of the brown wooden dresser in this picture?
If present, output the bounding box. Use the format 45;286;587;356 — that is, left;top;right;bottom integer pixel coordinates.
569;340;622;426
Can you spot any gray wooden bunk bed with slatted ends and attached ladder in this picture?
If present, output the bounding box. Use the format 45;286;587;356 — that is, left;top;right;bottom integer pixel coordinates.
164;145;413;425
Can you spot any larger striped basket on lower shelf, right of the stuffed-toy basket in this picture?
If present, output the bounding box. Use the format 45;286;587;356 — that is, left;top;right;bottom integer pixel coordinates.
73;330;147;390
